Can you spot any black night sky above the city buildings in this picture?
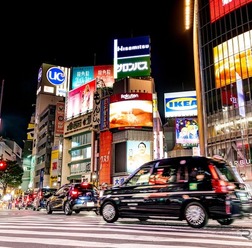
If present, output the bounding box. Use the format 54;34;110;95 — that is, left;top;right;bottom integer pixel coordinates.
0;0;195;147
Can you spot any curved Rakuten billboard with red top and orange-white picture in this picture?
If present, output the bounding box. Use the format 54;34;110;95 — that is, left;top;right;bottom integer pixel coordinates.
109;93;153;129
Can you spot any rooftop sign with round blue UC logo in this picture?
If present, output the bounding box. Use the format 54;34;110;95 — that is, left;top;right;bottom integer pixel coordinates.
37;63;71;97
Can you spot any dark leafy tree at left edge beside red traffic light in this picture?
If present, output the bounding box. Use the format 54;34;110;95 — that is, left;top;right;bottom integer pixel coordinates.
0;161;24;195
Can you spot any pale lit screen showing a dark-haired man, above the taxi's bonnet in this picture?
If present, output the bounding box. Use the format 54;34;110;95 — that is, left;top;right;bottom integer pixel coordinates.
127;141;151;173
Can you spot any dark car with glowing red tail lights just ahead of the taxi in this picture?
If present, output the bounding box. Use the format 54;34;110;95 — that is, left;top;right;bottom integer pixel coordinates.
46;182;99;215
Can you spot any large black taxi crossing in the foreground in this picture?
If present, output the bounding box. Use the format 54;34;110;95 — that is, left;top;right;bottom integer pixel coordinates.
100;156;252;228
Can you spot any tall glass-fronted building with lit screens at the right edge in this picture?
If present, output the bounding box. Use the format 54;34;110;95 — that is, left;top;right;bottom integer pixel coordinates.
194;0;252;179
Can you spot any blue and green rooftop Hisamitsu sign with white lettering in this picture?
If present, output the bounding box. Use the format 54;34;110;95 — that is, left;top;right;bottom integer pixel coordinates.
114;36;151;79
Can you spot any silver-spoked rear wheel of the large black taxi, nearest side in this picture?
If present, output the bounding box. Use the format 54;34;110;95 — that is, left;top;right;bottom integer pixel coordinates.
184;202;208;228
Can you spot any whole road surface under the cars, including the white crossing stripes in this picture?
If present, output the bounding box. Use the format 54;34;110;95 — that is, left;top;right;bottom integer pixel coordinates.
0;209;252;248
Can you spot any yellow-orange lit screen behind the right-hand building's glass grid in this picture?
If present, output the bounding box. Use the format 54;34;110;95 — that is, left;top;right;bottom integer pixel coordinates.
213;30;252;88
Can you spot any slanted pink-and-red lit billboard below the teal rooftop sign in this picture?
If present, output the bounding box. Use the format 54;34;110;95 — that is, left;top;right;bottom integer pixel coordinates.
66;80;96;119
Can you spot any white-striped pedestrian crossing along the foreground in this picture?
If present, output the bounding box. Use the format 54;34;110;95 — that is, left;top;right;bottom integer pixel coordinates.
0;216;252;248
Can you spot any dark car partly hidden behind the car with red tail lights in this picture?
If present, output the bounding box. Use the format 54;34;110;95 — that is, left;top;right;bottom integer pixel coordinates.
33;187;57;211
